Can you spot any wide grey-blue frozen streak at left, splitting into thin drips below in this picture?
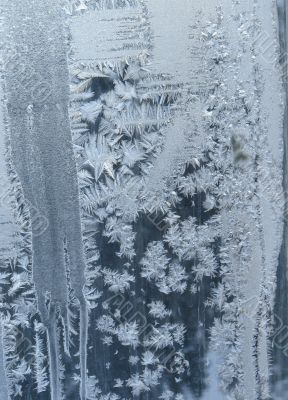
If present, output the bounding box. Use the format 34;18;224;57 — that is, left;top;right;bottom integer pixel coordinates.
1;0;87;400
